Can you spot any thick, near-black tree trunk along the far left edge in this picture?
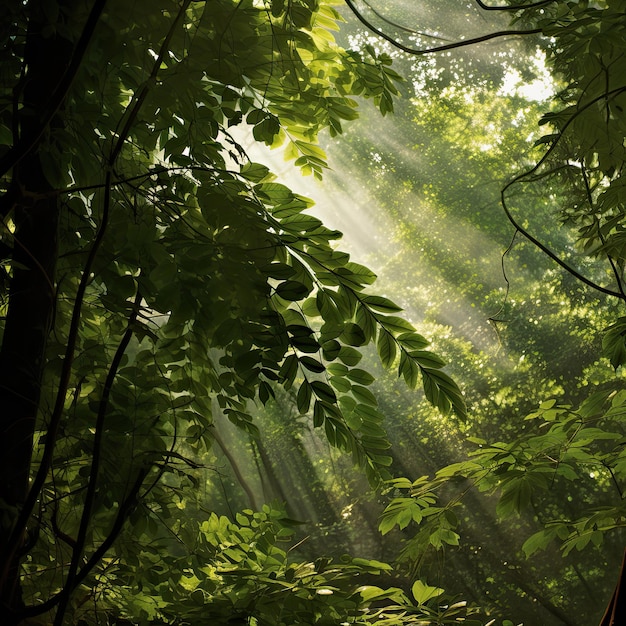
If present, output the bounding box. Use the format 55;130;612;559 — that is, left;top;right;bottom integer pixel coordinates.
0;2;72;624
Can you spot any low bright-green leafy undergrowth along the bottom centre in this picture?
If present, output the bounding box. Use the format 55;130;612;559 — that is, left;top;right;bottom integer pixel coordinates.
102;505;474;626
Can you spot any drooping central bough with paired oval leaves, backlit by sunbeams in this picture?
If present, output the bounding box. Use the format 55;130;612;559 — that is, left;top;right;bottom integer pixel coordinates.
212;164;466;483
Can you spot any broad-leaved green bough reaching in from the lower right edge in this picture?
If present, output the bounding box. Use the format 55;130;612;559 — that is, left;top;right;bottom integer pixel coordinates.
379;390;626;560
